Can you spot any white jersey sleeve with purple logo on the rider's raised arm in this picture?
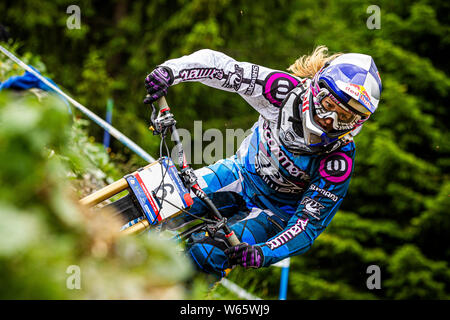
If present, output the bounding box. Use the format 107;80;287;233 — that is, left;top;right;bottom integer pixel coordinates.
161;49;301;119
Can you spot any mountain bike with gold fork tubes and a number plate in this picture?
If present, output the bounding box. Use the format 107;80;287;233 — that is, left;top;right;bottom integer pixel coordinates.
80;97;240;246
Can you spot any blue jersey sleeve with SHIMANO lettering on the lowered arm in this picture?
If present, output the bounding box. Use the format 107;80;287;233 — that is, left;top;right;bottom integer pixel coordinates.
257;142;355;266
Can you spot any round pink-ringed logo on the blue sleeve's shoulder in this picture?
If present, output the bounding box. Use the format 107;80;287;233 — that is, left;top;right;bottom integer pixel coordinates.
319;152;353;183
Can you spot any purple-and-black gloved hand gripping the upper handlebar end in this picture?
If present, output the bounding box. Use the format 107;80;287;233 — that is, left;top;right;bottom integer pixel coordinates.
144;67;174;104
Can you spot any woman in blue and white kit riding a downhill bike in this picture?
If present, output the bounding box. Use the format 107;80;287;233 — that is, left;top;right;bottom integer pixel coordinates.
144;46;382;276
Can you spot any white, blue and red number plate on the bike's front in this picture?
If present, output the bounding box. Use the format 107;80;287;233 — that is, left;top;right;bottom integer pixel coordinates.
125;157;193;225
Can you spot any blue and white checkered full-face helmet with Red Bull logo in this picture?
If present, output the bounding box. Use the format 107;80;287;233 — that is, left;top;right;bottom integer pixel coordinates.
299;53;382;149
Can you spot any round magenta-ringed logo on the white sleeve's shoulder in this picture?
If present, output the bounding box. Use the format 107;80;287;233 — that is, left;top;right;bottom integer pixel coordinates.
263;72;299;107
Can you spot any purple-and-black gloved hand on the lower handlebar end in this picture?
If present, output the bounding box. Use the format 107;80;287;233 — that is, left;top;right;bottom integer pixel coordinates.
225;242;264;268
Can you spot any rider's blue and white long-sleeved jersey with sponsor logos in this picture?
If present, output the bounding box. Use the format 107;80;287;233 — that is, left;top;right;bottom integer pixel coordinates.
162;49;355;266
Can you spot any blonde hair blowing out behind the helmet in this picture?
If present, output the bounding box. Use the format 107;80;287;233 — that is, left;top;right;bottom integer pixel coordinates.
287;46;342;79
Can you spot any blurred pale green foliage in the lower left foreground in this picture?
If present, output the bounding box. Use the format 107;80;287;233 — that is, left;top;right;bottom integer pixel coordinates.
0;93;202;299
